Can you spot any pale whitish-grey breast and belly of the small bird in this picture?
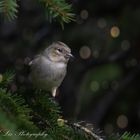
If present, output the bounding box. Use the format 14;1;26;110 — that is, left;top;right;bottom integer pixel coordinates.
31;57;67;90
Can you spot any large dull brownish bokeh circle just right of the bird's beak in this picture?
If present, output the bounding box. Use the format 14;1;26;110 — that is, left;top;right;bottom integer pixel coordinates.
79;46;91;59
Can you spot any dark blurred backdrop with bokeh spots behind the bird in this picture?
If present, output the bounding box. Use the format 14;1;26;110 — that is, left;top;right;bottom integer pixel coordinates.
0;0;140;135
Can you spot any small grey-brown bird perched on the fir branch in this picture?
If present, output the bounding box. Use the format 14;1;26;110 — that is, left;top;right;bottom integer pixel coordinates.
29;41;74;97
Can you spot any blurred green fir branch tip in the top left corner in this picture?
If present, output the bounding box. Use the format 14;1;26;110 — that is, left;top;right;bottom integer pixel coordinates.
0;0;18;20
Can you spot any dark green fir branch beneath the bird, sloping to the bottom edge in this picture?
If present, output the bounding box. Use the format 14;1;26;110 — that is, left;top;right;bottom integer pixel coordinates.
30;90;92;140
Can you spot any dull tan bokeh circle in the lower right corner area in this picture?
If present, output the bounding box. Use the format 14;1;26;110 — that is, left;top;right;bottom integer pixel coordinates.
117;115;128;129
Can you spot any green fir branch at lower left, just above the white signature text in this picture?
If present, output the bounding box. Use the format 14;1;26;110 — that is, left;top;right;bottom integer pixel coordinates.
0;89;38;131
